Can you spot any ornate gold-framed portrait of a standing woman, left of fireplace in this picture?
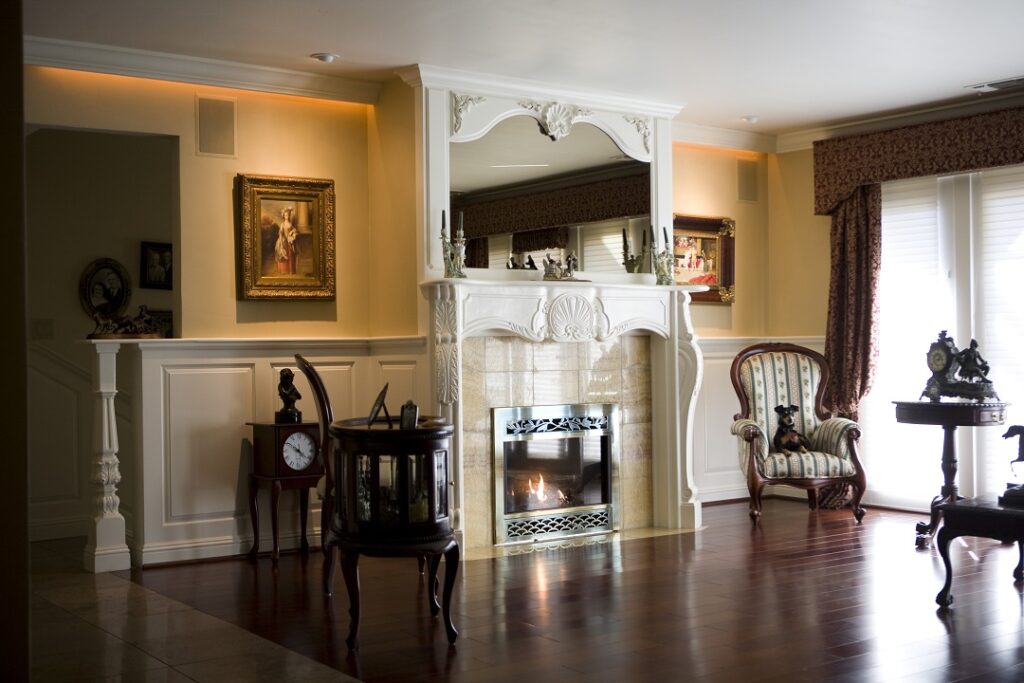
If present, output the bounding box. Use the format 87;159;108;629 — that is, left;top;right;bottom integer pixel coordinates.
236;174;335;300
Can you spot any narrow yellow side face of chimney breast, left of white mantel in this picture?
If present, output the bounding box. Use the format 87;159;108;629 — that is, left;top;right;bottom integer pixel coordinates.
369;79;420;337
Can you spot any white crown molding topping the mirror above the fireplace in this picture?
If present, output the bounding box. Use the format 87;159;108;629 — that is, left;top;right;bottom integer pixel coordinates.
395;65;683;119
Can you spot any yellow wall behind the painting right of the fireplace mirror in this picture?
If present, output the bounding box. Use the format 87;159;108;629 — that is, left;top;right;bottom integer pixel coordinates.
672;143;769;337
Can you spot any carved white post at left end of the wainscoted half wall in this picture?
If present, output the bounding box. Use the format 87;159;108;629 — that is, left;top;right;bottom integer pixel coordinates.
83;341;131;572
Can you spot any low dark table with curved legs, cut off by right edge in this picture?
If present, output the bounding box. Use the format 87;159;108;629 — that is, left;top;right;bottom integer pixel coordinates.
935;499;1024;607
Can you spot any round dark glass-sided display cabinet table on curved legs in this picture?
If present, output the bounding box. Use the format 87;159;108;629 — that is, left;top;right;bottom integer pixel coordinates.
324;418;459;649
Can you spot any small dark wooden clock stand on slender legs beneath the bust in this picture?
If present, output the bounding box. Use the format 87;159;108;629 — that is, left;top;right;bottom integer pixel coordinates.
246;422;324;562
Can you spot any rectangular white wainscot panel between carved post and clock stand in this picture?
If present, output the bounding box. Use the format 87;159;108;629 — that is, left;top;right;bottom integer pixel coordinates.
164;365;255;522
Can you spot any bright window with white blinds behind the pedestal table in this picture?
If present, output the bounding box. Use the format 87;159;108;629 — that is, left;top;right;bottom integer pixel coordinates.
861;167;1024;509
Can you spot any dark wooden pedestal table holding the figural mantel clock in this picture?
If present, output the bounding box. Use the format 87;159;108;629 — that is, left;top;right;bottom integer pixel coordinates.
893;400;1007;548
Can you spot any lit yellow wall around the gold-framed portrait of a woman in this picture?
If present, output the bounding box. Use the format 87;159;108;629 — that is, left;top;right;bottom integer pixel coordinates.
25;67;371;337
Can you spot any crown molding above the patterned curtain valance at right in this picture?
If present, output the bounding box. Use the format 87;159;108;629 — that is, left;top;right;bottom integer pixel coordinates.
776;93;1024;154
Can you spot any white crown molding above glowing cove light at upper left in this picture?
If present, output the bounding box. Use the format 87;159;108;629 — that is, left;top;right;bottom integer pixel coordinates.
24;36;380;104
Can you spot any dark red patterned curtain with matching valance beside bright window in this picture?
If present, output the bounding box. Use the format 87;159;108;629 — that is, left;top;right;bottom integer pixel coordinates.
814;108;1024;419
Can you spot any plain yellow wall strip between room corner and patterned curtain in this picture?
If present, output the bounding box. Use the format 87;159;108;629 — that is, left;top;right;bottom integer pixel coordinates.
765;150;830;337
